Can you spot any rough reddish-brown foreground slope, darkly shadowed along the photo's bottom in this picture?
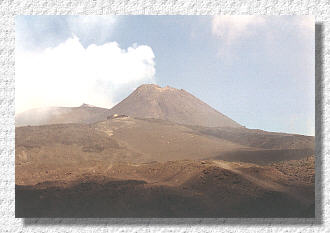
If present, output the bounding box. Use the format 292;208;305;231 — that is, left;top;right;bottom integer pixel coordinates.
16;160;314;217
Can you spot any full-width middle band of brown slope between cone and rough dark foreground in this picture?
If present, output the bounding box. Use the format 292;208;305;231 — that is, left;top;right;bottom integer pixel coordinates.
15;117;314;173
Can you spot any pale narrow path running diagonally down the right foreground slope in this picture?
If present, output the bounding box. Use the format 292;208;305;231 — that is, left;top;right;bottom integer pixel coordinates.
213;161;309;204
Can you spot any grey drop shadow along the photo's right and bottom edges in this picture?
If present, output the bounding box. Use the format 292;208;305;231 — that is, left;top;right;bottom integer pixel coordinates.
23;23;324;226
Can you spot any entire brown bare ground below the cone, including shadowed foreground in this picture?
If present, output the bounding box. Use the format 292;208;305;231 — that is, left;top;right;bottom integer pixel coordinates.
15;117;314;217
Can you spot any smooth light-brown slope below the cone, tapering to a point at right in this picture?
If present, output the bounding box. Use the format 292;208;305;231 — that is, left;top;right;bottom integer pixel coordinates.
16;117;248;168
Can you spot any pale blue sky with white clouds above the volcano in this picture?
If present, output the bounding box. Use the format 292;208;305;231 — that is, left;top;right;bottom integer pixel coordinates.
16;16;315;135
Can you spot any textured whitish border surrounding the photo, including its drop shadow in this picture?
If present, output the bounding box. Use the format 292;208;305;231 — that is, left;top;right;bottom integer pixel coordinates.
0;0;330;233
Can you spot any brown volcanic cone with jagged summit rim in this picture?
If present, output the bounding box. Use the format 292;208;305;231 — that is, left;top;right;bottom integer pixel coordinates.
110;84;241;127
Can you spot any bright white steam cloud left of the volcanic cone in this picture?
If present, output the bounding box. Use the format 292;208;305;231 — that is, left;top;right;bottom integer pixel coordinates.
16;36;155;113
